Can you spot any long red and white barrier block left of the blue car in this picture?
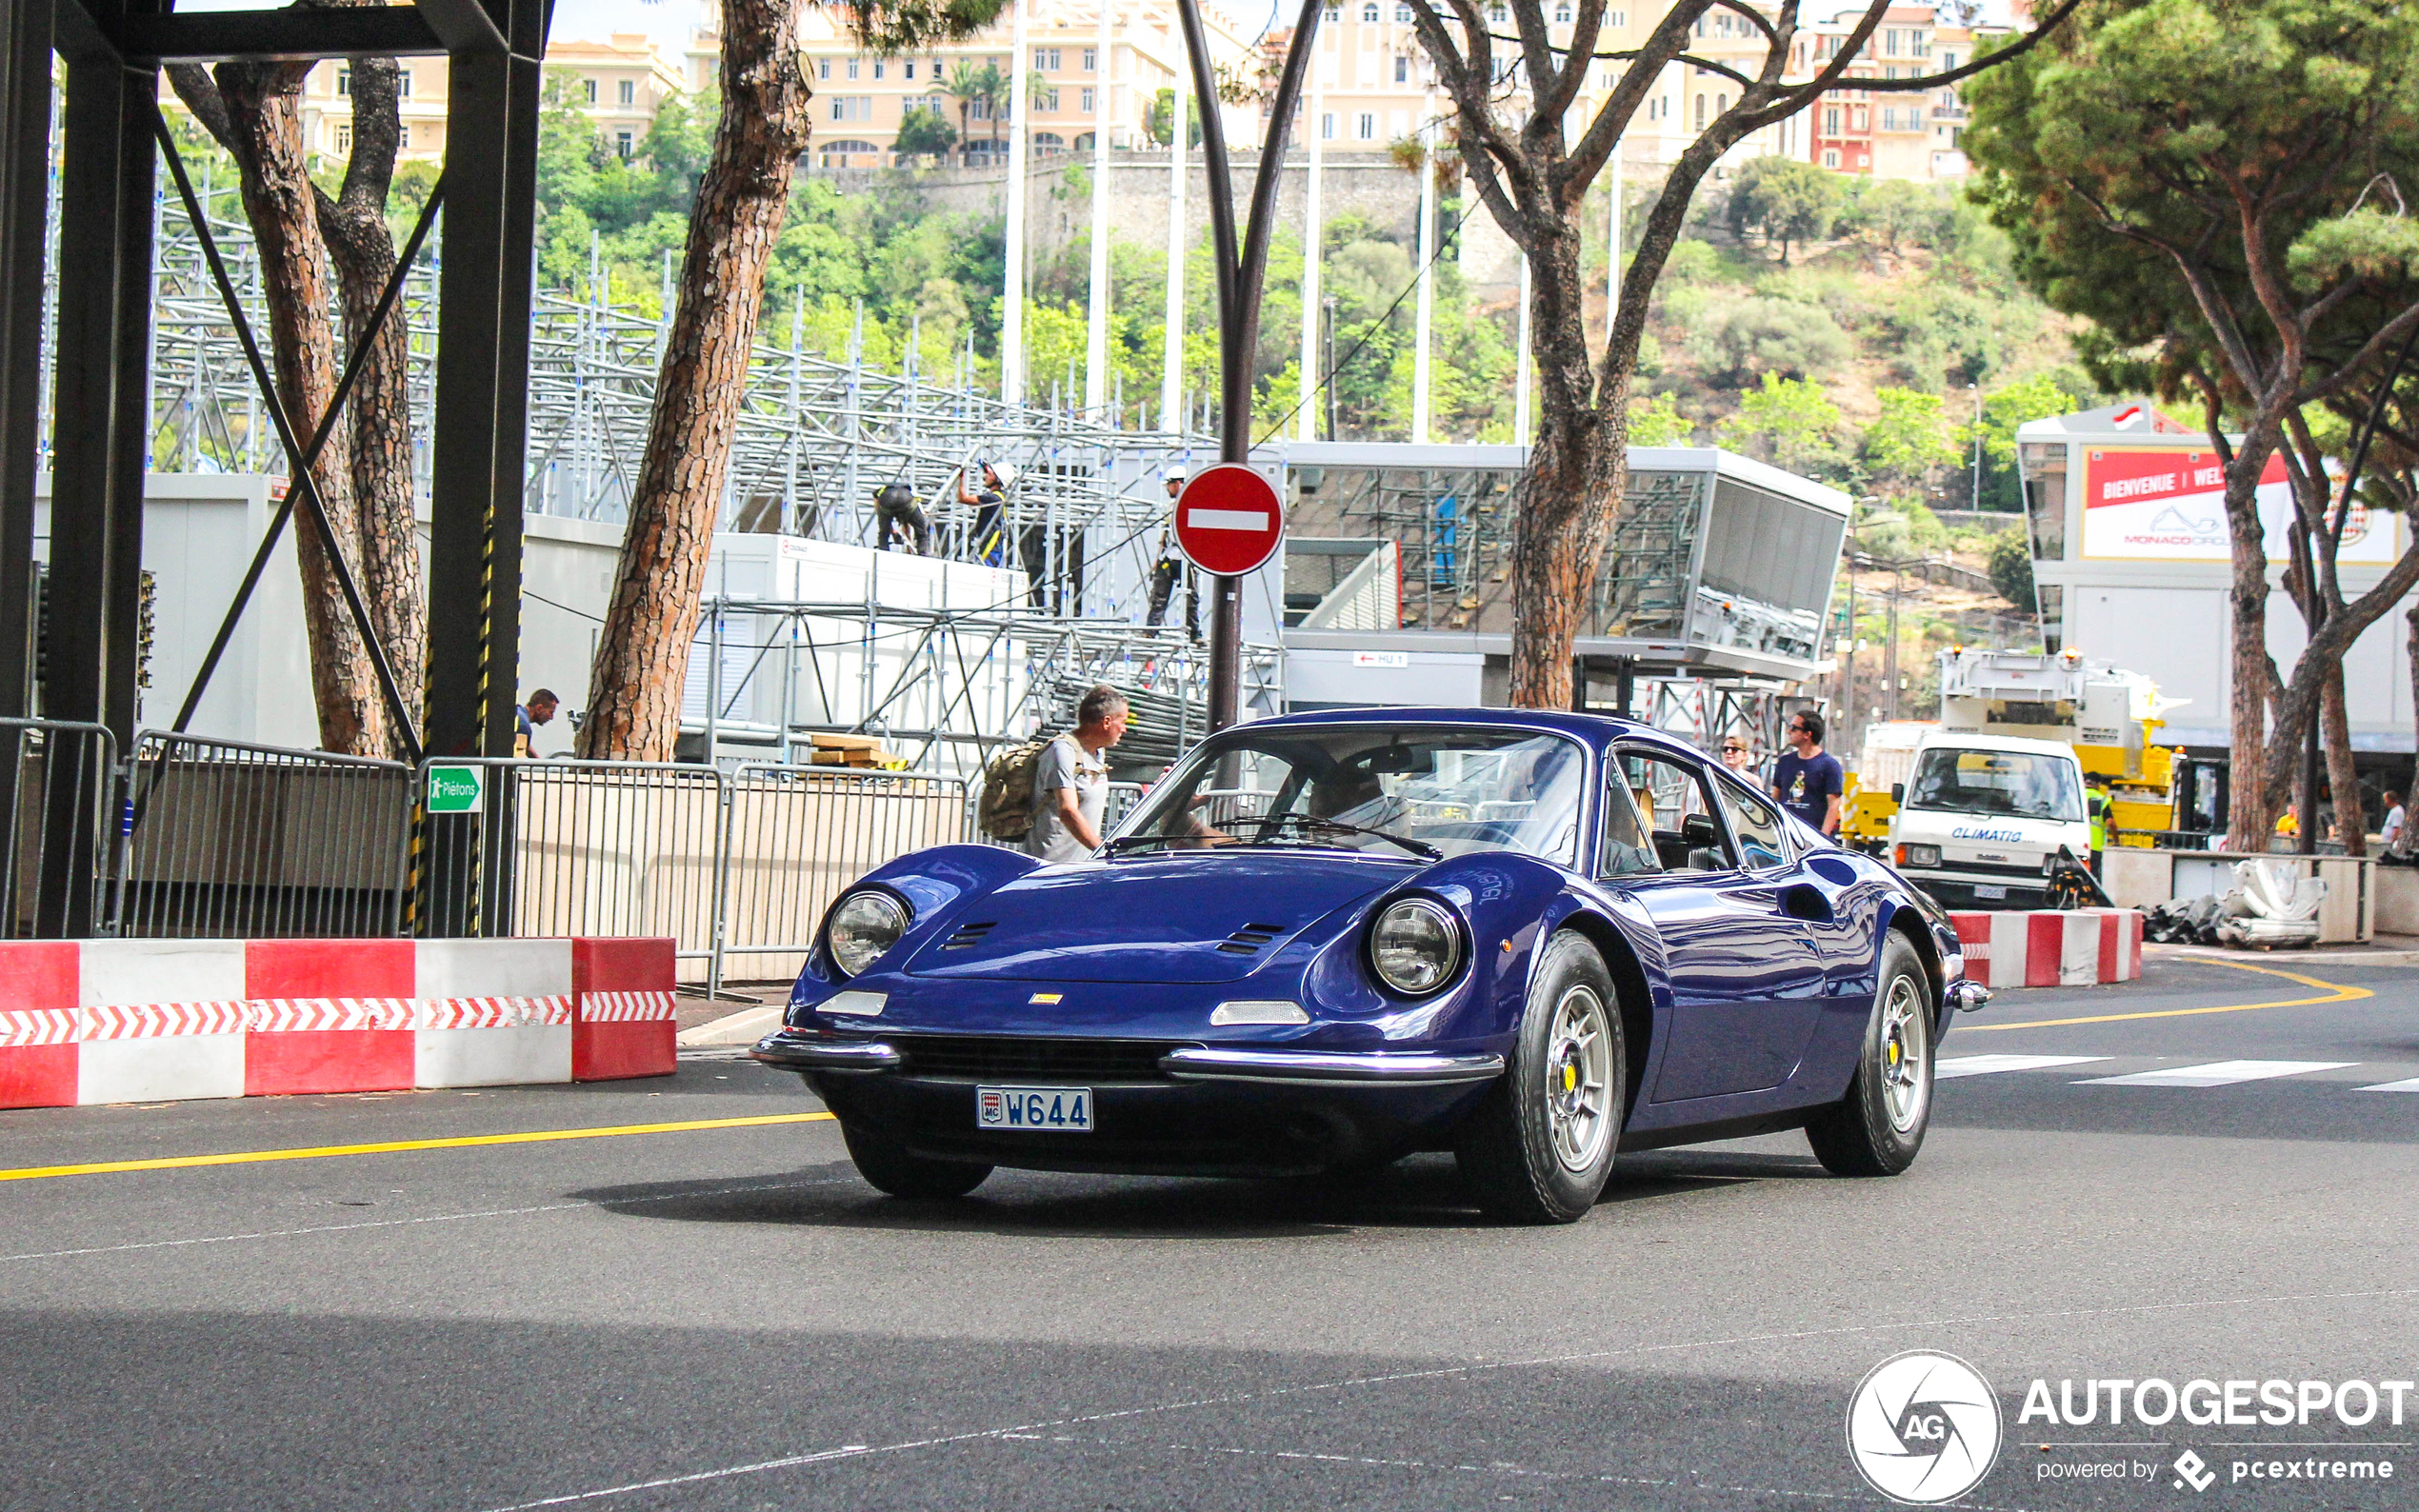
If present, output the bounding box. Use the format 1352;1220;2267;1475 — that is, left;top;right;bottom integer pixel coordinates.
0;939;677;1108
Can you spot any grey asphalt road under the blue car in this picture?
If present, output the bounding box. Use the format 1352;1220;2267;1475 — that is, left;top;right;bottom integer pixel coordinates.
0;956;2419;1512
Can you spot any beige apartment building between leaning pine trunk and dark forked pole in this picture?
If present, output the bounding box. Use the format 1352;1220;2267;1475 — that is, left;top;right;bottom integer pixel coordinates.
798;0;1255;167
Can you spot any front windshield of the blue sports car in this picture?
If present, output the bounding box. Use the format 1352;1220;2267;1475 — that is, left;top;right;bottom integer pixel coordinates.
1110;724;1587;866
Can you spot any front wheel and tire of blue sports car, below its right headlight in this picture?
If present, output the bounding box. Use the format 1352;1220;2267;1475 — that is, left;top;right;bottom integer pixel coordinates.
1454;931;1630;1224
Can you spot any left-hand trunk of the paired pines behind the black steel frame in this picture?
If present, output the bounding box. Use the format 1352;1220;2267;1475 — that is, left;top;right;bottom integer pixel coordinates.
174;63;390;755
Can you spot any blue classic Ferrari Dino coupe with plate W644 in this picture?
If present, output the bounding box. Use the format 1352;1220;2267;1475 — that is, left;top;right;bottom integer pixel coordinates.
754;708;1989;1222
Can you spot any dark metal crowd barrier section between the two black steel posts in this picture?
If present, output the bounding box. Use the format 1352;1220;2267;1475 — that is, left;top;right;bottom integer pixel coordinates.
116;730;413;939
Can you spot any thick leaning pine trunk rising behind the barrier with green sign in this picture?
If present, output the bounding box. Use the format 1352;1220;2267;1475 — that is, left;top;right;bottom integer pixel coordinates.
578;0;812;762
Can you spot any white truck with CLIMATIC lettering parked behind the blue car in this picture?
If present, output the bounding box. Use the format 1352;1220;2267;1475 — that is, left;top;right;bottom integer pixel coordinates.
1889;728;2092;907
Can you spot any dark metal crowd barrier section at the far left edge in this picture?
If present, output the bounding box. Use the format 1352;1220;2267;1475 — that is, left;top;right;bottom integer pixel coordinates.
0;719;118;939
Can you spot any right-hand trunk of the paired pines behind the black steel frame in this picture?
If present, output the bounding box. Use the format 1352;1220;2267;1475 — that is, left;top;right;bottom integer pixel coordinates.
317;58;429;740
